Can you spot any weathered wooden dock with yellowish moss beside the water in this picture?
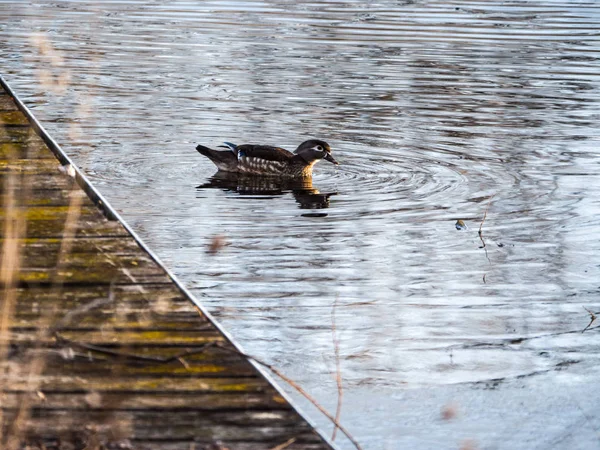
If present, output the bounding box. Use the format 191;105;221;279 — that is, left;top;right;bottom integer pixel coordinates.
0;78;332;450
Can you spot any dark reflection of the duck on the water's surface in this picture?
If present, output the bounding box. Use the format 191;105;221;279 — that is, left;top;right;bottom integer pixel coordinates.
196;171;337;209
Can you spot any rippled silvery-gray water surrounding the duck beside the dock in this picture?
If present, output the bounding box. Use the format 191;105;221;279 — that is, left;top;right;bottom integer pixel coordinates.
0;0;600;449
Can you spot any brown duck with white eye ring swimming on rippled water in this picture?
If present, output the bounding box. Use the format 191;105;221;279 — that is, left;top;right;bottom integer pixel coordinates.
196;139;338;178
